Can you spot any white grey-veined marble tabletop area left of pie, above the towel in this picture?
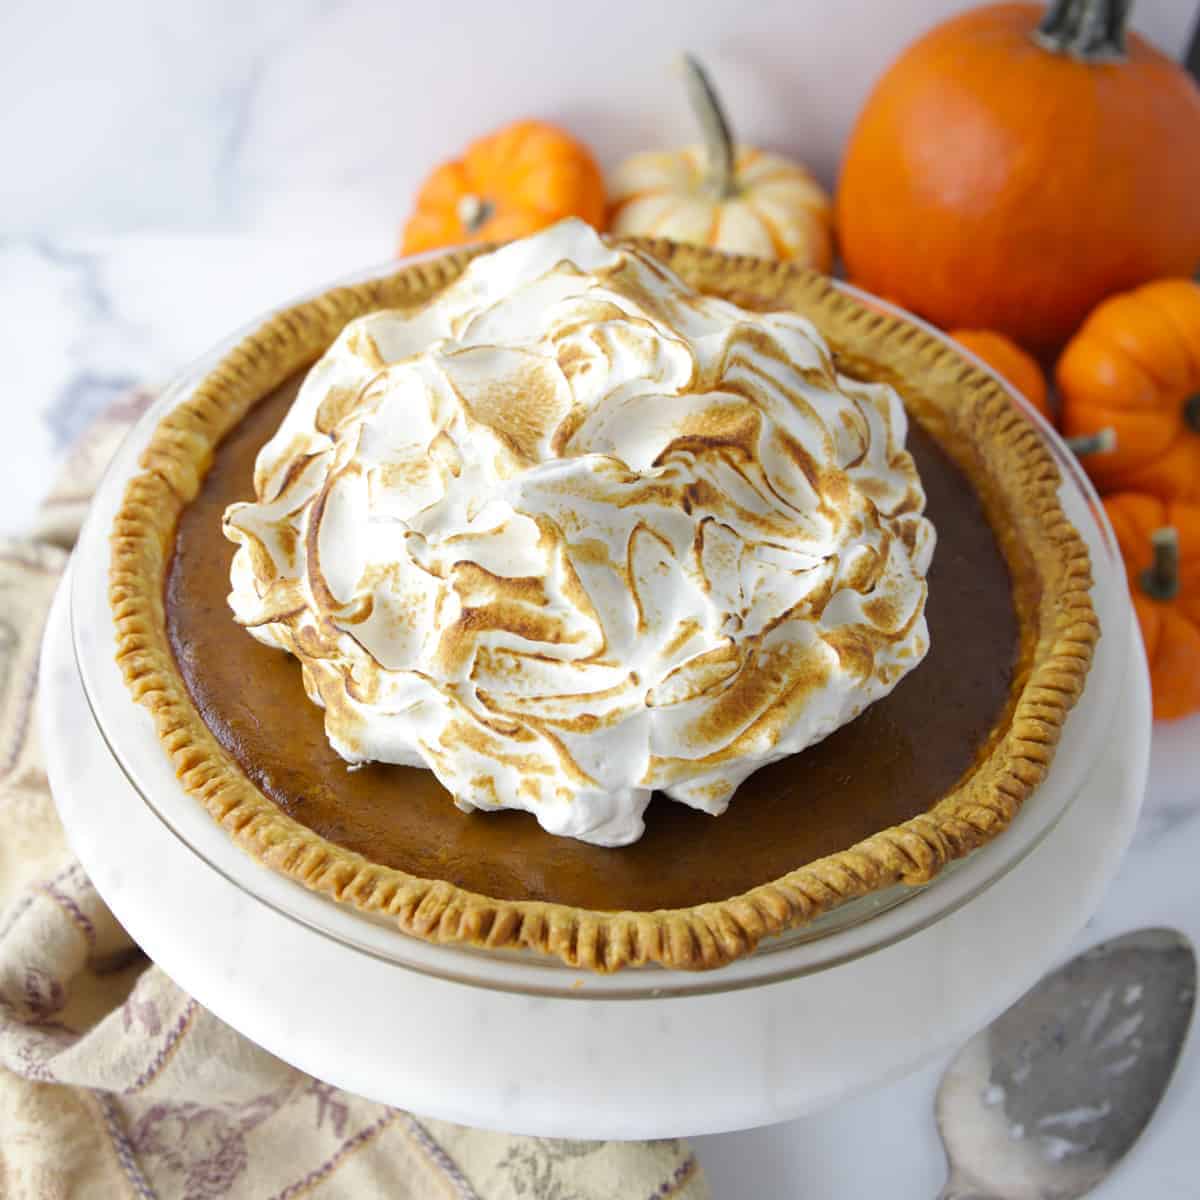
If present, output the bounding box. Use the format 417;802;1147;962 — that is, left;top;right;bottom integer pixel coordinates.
0;227;381;534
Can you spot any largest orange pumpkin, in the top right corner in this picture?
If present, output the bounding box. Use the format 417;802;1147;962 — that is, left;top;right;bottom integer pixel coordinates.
836;0;1200;354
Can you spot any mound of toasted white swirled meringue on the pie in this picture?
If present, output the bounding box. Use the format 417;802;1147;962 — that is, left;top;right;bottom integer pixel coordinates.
224;221;935;845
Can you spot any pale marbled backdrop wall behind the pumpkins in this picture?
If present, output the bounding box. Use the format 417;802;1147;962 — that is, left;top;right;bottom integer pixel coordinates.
0;0;1196;231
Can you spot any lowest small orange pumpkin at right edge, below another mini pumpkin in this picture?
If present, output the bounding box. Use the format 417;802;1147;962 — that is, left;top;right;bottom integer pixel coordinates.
1104;492;1200;720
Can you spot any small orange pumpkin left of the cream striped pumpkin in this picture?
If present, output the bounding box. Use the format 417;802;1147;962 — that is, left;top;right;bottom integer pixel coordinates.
400;121;605;254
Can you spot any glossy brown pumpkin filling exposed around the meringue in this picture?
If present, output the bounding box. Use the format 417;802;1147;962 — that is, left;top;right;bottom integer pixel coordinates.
166;364;1037;911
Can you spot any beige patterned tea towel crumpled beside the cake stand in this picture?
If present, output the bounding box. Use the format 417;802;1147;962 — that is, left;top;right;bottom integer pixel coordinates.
0;392;709;1200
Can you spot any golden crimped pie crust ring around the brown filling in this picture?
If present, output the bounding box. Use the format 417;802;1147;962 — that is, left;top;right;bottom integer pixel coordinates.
109;239;1099;971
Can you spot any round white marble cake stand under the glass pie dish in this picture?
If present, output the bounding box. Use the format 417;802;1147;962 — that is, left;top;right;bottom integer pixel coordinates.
41;566;1150;1138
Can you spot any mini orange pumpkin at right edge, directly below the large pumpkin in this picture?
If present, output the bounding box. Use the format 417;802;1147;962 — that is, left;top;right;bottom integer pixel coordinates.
1055;277;1200;502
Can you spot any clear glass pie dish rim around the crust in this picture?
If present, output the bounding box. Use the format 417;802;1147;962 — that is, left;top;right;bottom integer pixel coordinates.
70;264;1130;998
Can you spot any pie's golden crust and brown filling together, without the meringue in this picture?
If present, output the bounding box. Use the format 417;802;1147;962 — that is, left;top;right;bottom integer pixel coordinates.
109;231;1099;972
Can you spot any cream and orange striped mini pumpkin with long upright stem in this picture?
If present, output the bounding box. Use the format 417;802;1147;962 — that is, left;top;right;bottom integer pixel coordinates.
608;56;833;271
